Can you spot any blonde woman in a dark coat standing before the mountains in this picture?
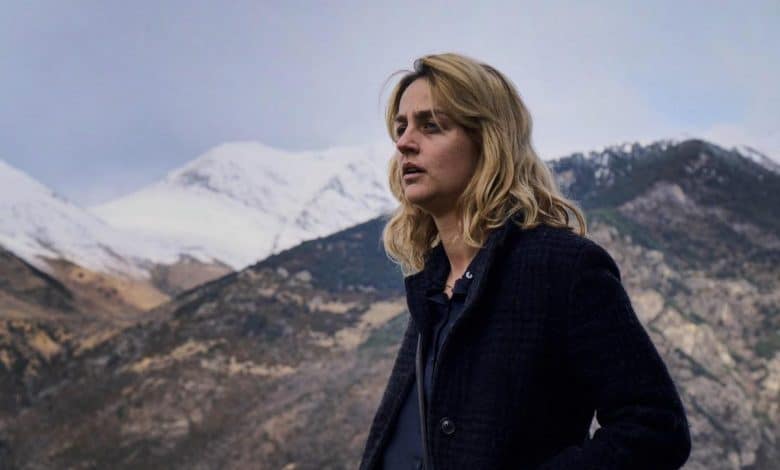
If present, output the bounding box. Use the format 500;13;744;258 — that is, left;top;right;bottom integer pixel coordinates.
361;54;690;470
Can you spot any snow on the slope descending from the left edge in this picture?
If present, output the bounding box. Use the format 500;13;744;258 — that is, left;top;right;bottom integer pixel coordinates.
0;160;176;277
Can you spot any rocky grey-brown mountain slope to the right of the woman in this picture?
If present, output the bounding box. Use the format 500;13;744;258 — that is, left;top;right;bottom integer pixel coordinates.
553;140;780;468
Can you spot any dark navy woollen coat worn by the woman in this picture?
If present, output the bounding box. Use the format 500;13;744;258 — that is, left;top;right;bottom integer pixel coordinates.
360;220;691;470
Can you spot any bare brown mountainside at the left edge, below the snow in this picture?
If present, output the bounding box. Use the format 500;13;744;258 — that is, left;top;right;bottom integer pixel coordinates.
0;248;168;424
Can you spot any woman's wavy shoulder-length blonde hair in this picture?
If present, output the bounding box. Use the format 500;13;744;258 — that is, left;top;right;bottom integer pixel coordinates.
382;53;587;275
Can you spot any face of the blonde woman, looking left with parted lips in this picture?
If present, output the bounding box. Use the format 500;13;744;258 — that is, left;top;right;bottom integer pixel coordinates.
395;78;479;216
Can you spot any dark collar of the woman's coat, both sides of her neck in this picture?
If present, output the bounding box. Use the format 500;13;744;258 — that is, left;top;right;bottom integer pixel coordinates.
404;215;521;332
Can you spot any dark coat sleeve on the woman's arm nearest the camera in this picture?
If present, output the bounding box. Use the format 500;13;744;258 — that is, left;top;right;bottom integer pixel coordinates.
539;242;691;470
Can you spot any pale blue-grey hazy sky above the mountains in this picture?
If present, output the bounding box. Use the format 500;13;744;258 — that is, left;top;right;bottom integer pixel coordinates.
0;0;780;205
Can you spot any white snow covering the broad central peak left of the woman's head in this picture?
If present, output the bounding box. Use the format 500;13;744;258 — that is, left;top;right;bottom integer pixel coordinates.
91;142;396;269
